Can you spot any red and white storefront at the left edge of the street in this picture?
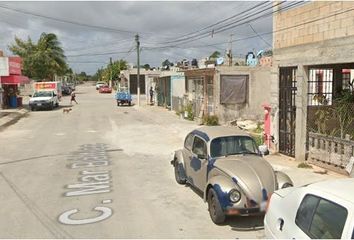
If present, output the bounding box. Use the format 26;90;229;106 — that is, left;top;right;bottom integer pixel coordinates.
0;57;29;108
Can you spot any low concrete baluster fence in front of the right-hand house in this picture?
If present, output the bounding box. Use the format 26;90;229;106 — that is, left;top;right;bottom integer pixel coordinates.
308;132;354;174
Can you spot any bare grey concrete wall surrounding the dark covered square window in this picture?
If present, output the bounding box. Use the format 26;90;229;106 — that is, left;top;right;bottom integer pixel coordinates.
214;66;271;123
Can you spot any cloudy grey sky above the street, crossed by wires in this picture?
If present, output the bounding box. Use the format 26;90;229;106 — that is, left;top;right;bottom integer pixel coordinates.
0;1;272;74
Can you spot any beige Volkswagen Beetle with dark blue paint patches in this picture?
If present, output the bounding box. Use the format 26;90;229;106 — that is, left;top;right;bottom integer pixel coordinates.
171;126;293;224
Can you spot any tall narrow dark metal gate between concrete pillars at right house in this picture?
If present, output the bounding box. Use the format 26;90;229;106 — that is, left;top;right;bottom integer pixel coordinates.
279;67;297;157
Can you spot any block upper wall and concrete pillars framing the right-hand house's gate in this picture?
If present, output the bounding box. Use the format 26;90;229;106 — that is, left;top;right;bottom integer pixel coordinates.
271;1;354;161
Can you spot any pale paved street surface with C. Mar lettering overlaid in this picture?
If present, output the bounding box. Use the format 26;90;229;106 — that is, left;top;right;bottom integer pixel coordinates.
0;85;263;238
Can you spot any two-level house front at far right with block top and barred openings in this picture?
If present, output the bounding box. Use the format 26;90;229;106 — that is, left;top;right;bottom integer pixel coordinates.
271;1;354;172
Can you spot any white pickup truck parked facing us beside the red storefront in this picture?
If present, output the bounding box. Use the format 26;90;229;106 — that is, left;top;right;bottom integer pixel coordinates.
29;91;59;111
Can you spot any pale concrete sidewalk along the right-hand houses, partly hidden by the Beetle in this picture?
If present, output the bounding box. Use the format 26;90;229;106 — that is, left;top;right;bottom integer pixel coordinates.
138;104;346;186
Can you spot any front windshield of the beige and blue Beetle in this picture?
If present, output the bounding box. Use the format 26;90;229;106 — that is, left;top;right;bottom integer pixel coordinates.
210;136;259;157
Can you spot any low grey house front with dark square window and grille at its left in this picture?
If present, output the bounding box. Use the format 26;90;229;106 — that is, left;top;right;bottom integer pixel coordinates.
185;66;271;123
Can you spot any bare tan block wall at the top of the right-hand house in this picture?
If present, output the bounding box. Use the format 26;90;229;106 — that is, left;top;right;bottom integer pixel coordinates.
273;1;354;48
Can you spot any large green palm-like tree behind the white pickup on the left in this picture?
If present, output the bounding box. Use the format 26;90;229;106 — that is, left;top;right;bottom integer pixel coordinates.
9;33;68;80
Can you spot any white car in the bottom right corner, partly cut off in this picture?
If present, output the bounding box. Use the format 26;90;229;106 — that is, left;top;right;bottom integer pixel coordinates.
264;178;354;239
